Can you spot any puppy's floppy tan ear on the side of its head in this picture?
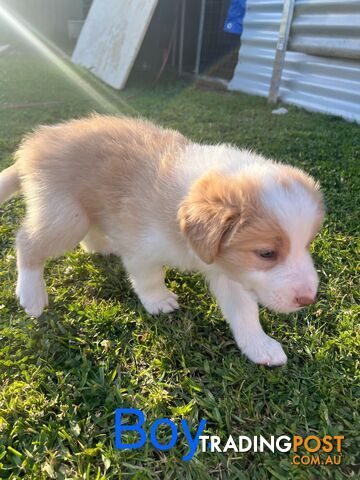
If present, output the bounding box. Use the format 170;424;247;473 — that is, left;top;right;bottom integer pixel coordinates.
177;172;242;263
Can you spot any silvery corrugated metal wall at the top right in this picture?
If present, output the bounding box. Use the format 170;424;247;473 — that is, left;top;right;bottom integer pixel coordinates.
229;0;360;122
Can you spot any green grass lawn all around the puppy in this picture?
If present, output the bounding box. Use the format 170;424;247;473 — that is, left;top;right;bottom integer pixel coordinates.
0;50;360;480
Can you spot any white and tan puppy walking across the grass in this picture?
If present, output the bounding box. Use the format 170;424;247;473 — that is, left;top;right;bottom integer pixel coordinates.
0;116;323;365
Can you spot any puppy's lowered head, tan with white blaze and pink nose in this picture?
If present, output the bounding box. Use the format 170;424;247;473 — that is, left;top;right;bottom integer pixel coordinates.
178;164;324;313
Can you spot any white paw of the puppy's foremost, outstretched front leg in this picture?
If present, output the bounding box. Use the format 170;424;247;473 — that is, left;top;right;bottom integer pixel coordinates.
242;334;287;367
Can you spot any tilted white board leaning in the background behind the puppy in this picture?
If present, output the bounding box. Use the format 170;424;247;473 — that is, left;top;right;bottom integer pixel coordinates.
72;0;158;89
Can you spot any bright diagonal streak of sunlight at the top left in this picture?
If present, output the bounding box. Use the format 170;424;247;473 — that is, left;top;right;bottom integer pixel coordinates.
0;0;136;115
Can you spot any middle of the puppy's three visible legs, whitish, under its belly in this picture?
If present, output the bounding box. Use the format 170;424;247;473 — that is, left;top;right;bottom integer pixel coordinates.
123;258;179;315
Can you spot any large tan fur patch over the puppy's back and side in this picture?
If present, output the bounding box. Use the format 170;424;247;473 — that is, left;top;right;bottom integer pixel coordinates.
16;115;189;253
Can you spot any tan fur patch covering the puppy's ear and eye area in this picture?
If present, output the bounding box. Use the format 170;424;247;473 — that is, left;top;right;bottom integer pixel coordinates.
178;172;290;270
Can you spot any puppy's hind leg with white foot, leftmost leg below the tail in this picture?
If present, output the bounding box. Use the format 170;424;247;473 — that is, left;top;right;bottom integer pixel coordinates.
16;197;89;317
